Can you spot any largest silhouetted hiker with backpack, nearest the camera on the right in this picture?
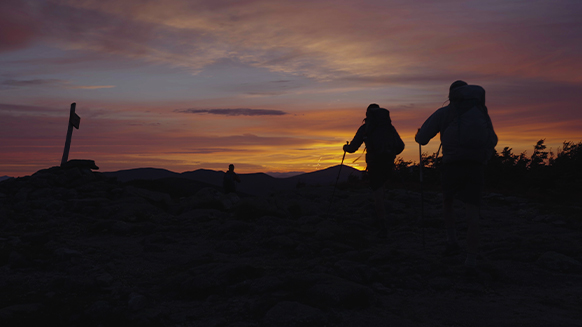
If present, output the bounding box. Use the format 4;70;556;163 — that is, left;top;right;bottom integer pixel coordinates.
415;81;497;267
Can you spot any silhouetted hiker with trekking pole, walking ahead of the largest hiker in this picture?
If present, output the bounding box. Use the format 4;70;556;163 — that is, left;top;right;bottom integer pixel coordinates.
344;103;404;237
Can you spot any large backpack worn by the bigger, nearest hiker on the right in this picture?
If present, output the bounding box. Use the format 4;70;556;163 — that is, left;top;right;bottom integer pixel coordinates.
441;85;497;162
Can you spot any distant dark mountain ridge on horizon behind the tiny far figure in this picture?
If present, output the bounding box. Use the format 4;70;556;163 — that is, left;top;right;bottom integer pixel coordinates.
104;166;362;195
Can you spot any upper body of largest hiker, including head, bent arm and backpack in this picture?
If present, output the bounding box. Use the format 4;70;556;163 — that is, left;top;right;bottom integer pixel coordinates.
415;85;497;164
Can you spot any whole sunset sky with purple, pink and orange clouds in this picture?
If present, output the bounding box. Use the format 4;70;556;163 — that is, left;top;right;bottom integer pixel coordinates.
0;0;582;177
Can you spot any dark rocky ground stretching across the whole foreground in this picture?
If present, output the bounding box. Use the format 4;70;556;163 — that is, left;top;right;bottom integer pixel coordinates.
0;168;582;327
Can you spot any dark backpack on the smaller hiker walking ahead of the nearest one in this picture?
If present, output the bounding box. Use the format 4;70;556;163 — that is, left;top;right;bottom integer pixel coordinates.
364;108;404;157
